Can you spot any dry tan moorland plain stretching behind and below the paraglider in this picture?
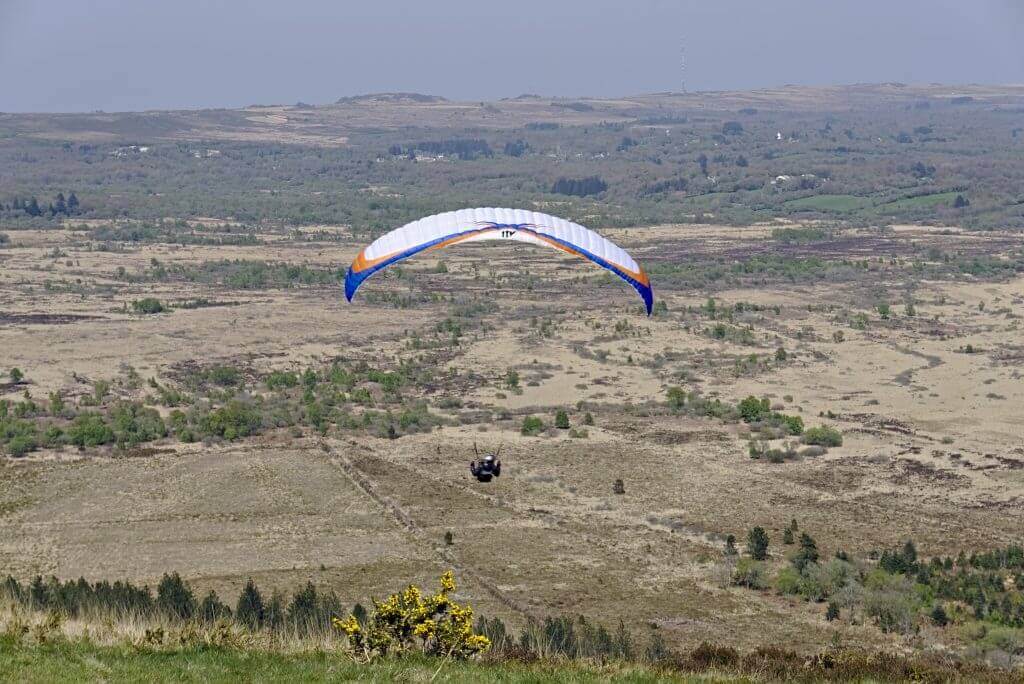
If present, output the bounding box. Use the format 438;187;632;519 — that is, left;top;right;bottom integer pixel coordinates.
0;216;1024;651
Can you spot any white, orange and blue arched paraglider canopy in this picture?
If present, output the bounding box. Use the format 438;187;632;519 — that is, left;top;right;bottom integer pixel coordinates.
345;208;654;315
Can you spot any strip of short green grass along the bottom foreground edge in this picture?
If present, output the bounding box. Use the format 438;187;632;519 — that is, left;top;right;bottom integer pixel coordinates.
0;640;733;682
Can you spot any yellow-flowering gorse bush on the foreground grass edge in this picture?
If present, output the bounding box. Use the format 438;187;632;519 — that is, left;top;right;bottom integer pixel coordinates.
334;570;490;659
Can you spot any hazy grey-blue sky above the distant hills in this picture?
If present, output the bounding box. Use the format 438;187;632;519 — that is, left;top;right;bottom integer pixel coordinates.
0;0;1024;112
